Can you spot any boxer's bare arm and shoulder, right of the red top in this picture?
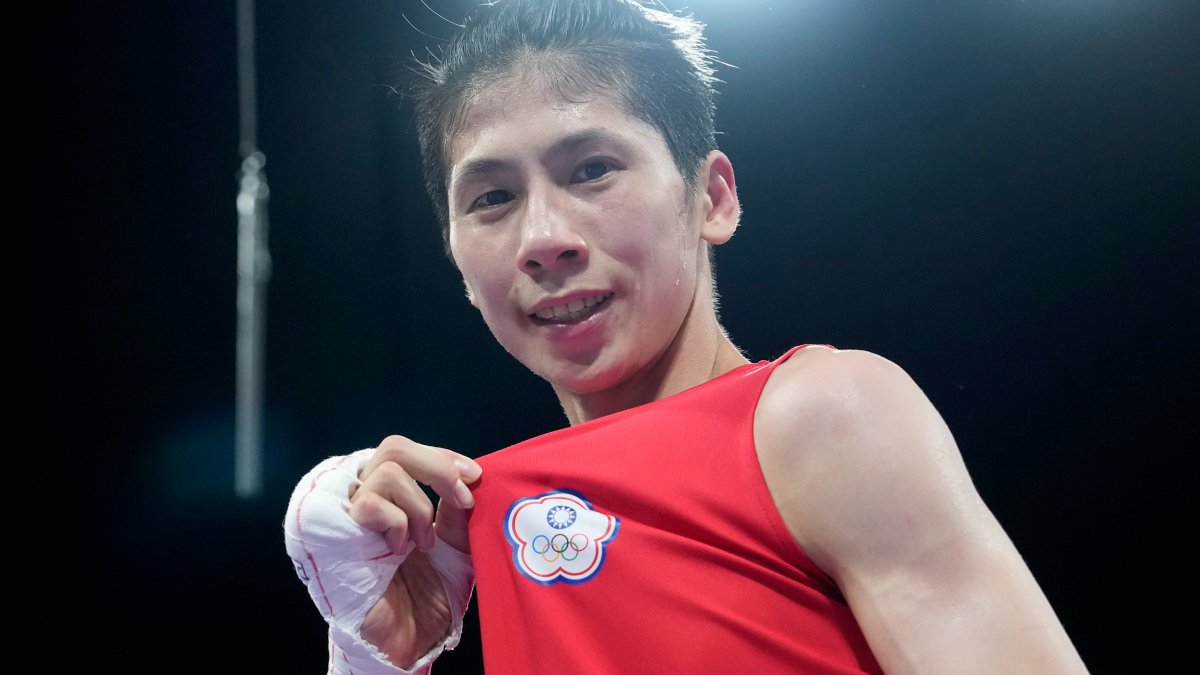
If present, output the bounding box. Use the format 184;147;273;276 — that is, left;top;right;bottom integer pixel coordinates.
755;350;1084;673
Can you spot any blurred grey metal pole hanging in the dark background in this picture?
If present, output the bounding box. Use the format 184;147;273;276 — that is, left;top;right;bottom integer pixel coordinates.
234;0;271;497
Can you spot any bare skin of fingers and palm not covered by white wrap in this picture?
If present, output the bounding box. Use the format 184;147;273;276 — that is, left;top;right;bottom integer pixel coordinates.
348;436;482;665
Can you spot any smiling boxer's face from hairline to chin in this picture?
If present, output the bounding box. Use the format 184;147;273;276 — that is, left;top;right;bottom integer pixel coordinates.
449;79;710;394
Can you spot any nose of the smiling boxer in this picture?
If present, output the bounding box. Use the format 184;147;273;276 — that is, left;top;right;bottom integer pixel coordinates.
517;183;588;274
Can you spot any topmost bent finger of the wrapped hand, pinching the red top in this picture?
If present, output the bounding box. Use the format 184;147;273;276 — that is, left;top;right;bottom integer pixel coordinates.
359;436;482;508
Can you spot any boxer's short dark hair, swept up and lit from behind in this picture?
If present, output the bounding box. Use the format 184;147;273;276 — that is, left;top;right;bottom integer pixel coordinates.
402;0;718;251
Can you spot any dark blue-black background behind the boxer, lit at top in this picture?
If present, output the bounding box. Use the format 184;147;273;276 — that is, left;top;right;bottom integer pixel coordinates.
44;0;1200;673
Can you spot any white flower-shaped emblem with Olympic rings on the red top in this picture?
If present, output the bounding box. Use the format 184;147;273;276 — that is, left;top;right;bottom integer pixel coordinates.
504;490;620;586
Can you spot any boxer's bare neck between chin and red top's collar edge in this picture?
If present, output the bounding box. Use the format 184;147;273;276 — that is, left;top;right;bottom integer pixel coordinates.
554;294;750;426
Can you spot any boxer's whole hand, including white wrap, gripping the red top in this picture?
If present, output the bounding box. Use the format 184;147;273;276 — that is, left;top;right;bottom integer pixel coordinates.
283;436;482;674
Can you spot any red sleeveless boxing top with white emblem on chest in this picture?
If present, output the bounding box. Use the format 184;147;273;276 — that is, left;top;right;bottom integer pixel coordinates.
469;347;881;675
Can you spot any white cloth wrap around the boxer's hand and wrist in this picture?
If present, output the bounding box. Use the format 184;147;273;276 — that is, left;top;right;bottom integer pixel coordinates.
283;448;475;675
